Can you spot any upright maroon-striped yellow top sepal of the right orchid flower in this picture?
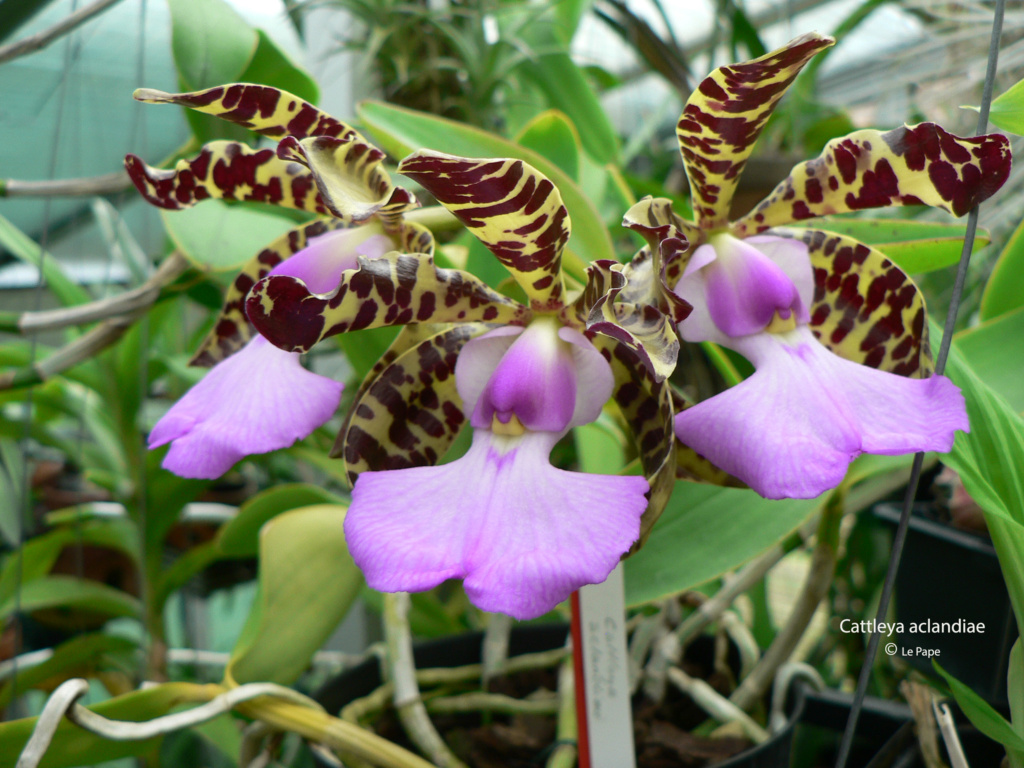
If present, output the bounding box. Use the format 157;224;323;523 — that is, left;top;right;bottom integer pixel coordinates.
676;33;836;229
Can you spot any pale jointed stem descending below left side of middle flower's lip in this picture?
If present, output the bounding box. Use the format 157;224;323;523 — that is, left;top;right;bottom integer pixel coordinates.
384;592;467;768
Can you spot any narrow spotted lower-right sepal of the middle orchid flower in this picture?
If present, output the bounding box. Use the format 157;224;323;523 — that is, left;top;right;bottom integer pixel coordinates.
593;336;676;551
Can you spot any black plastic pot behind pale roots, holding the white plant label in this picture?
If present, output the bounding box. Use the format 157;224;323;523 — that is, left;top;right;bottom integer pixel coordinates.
314;625;804;768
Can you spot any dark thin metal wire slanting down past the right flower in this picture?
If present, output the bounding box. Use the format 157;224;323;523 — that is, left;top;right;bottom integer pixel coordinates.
836;0;1006;768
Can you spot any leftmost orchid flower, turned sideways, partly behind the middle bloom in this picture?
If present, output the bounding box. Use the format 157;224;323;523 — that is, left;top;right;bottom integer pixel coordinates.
125;84;433;479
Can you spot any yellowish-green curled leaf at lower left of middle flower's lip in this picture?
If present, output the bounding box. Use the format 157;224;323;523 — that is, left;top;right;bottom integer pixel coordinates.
225;504;362;685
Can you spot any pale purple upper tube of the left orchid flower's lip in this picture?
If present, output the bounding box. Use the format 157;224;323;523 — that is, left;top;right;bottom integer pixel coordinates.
269;227;394;293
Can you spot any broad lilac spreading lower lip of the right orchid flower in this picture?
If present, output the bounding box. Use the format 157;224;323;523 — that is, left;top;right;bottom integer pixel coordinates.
676;327;968;499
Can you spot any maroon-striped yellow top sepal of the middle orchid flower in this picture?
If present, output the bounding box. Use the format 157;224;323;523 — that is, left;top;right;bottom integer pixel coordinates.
398;151;569;311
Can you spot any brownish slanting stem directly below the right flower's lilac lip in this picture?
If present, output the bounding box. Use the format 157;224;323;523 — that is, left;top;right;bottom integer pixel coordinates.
729;495;846;711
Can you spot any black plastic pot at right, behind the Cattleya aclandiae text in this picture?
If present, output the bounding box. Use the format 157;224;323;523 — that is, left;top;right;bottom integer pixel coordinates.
874;504;1017;707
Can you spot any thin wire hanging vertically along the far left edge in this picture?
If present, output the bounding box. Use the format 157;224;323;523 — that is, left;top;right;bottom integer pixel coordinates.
10;0;78;701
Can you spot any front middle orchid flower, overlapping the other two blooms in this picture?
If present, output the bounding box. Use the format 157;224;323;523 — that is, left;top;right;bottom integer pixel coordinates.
246;152;678;618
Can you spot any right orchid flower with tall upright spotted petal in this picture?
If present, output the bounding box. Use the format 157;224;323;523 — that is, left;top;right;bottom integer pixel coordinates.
625;34;1010;499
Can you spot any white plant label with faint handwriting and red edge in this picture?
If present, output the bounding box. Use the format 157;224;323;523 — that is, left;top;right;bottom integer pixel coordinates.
580;562;636;768
